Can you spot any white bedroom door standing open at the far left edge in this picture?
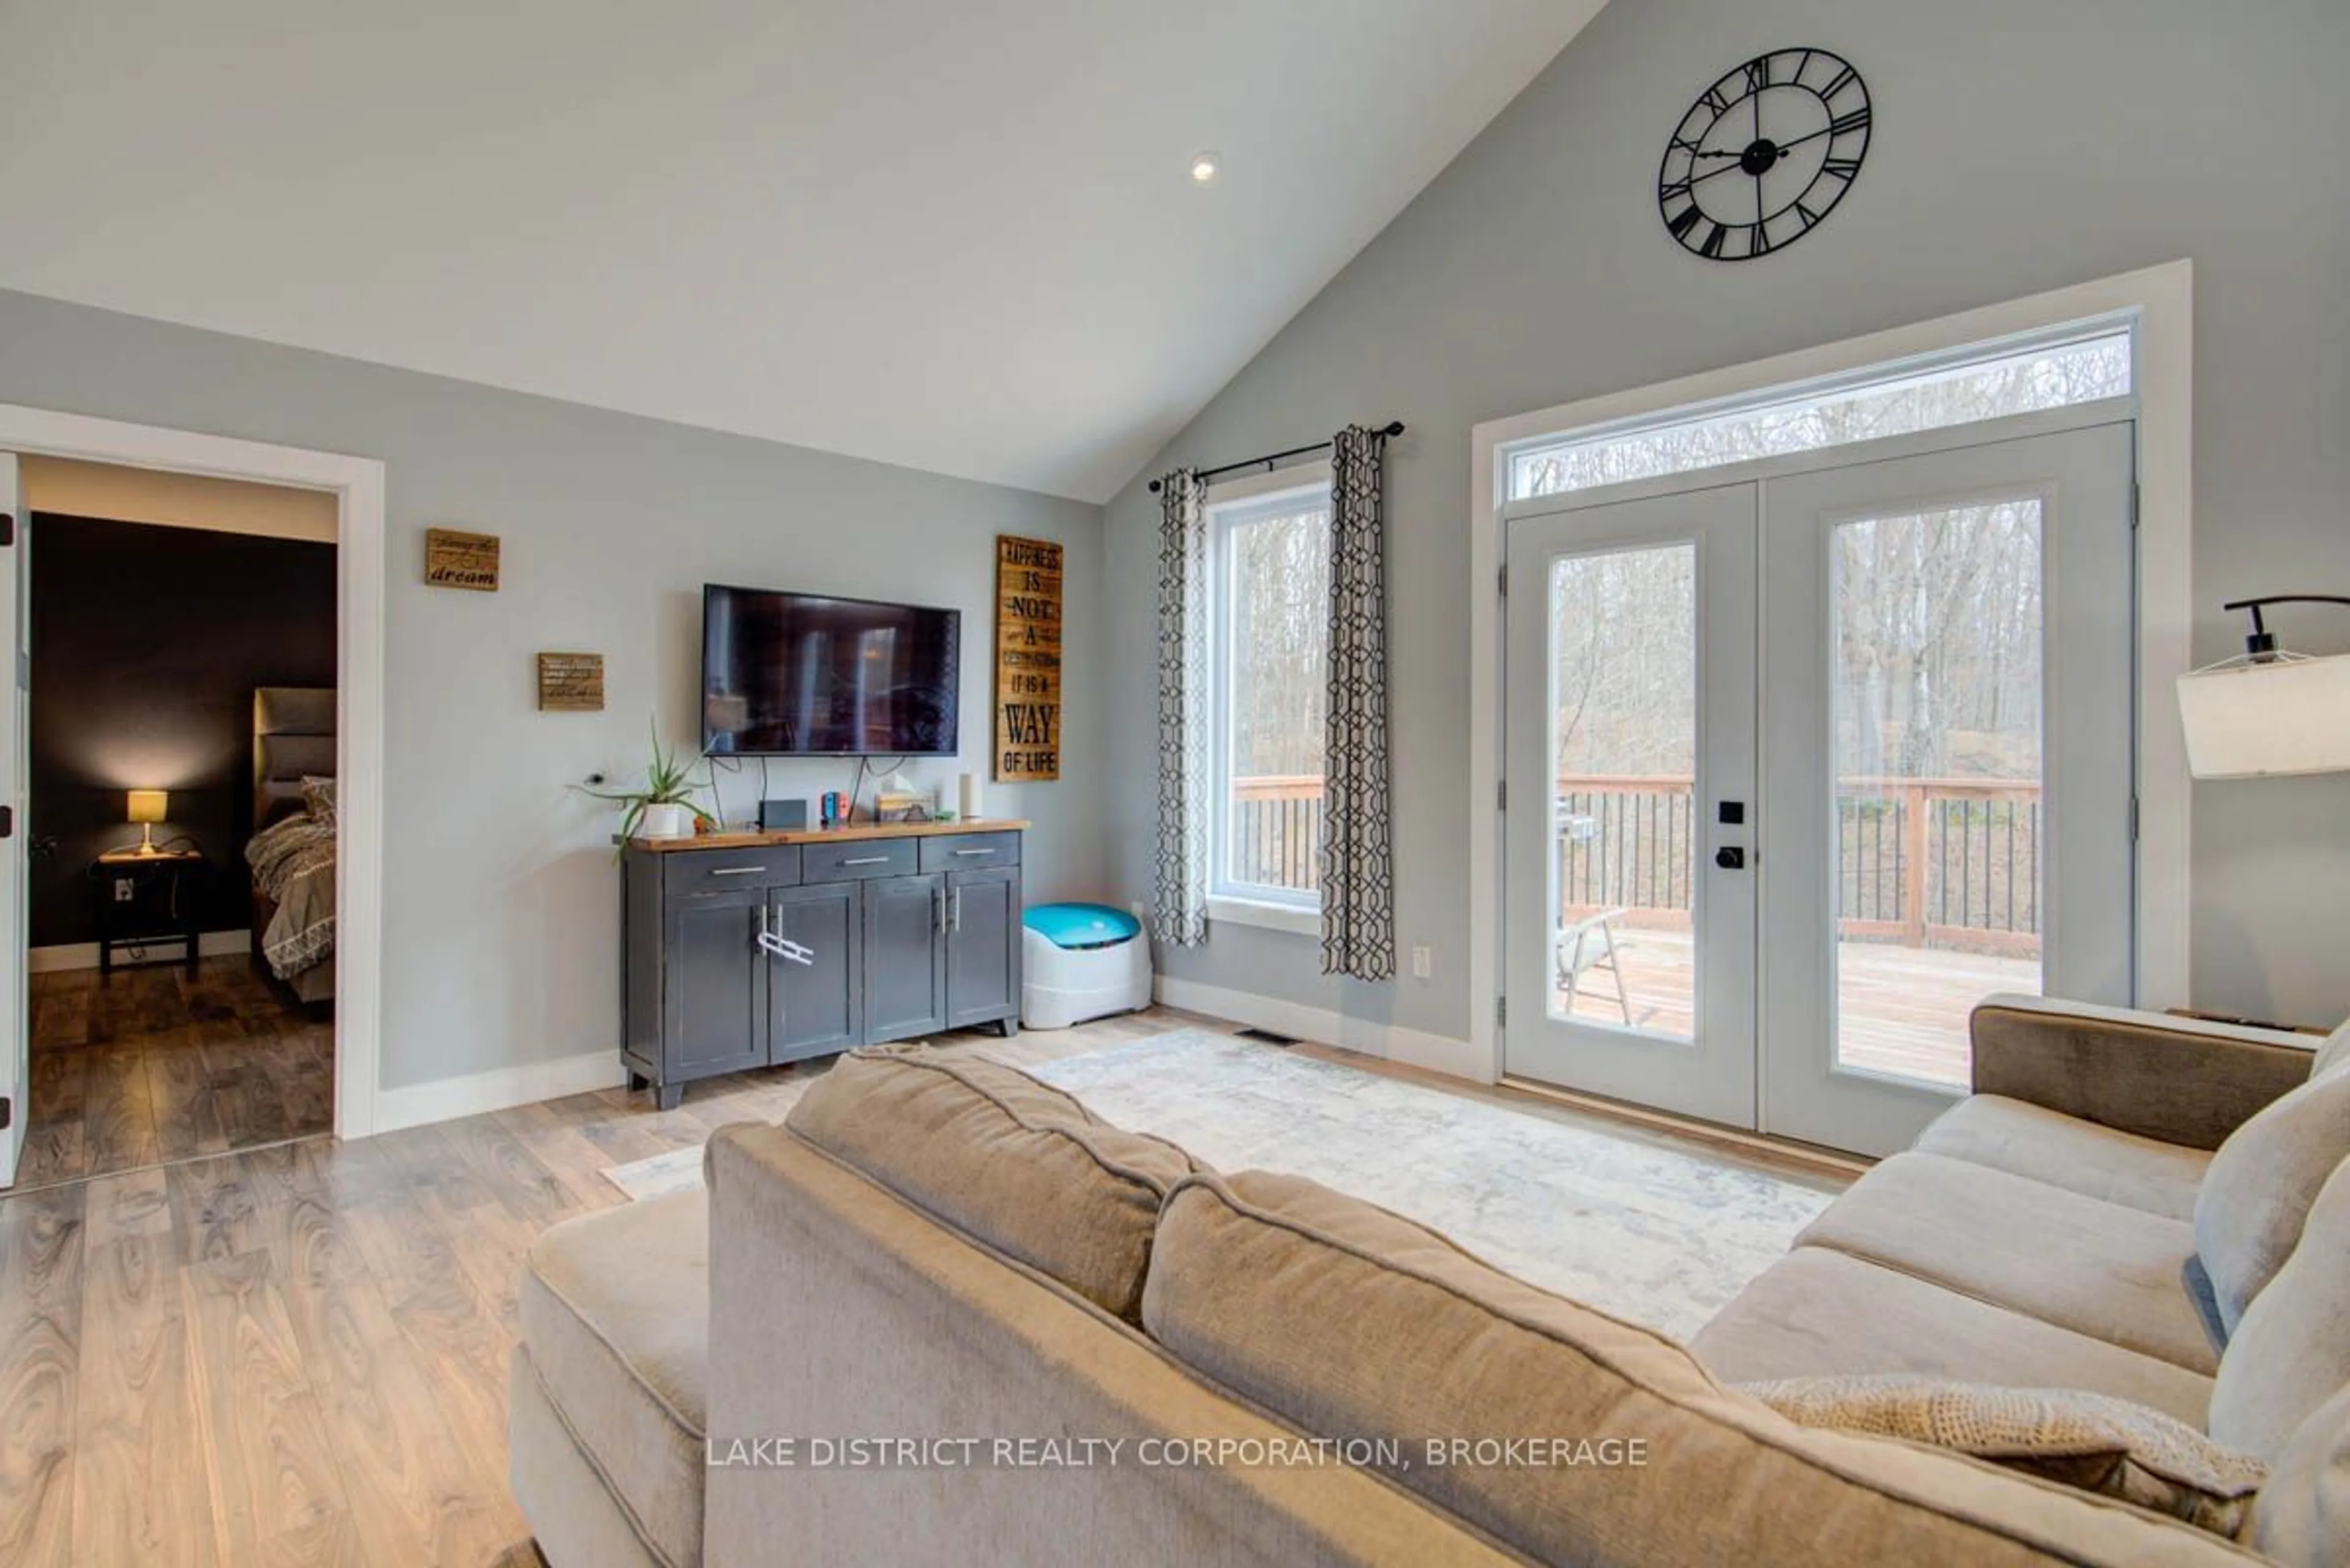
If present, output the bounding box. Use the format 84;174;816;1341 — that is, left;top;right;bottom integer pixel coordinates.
0;451;33;1187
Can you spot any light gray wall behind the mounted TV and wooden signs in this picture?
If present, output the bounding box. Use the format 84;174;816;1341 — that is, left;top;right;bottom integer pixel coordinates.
0;291;1107;1086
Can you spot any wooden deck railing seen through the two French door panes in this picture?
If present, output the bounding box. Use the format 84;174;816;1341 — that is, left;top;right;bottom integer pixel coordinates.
1556;774;2040;957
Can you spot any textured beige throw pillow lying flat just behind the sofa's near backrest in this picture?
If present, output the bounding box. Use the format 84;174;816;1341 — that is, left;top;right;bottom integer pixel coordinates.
1739;1375;2268;1537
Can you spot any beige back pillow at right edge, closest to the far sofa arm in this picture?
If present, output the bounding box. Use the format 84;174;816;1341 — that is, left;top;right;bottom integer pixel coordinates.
2195;1062;2350;1333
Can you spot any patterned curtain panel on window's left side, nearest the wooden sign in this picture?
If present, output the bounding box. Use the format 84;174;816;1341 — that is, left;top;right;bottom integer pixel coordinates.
1154;468;1208;947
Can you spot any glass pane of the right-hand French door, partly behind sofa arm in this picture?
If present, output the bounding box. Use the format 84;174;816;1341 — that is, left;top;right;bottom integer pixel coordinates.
1829;498;2045;1088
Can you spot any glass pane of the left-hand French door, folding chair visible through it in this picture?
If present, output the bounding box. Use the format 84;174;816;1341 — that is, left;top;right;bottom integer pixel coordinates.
1549;543;1696;1042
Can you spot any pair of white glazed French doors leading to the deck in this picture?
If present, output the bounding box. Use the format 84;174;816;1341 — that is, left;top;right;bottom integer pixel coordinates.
1504;411;2136;1154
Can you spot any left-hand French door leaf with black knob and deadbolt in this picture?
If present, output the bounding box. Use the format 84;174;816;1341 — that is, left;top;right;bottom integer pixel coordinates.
1504;484;1758;1126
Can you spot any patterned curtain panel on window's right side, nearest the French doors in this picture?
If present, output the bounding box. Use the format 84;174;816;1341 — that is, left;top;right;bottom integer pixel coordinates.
1323;425;1396;980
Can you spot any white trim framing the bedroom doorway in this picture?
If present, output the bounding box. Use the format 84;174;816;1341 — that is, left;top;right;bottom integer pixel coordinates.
0;405;386;1138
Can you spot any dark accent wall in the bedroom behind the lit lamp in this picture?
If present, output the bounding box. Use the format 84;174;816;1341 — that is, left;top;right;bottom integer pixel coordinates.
28;512;336;947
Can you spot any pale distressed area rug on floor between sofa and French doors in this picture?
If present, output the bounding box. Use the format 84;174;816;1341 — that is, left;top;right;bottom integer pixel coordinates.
606;1029;1833;1338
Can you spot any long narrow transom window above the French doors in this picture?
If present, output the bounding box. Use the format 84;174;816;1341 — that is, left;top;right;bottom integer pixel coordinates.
1509;319;2134;501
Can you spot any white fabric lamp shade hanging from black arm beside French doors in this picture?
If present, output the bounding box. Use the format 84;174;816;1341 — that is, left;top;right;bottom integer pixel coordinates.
2179;654;2350;778
